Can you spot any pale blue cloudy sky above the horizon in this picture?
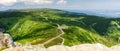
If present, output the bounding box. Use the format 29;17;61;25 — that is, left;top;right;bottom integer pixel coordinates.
0;0;120;10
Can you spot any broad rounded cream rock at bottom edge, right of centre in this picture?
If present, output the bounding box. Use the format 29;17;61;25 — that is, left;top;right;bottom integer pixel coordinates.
70;44;109;51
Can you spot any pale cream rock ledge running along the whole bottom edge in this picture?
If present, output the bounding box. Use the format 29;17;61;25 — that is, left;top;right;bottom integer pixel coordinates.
3;43;120;51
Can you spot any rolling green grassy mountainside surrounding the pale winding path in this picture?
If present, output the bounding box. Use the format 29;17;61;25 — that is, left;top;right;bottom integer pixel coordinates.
0;8;120;47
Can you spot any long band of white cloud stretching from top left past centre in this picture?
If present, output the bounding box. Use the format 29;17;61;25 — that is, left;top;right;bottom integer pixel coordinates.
0;0;67;6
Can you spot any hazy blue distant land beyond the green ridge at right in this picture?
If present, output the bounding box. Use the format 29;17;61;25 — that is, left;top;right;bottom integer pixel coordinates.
67;9;120;18
